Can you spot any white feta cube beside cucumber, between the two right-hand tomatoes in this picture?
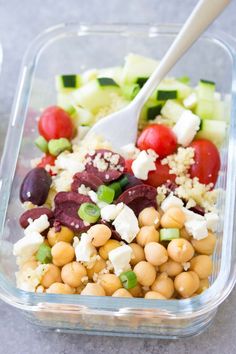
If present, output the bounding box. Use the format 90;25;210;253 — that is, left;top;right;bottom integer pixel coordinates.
172;110;201;146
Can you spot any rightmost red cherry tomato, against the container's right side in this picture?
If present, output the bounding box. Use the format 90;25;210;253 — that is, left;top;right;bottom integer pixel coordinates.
190;139;220;185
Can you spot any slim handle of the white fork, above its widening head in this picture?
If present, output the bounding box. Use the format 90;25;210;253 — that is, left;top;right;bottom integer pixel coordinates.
132;0;231;108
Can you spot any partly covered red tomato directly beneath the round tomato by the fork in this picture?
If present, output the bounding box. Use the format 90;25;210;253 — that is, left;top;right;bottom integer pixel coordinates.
144;160;176;187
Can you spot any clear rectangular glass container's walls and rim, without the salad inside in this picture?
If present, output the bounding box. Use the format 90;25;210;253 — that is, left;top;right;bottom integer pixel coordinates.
0;24;236;338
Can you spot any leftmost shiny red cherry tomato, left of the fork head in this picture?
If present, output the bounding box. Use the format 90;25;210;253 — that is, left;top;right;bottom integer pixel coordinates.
38;106;74;140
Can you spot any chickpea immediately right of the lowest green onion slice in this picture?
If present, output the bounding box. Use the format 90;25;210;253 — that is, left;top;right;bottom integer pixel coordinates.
133;261;156;286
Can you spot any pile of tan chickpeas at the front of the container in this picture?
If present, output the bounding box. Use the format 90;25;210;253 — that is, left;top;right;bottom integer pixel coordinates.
22;207;216;299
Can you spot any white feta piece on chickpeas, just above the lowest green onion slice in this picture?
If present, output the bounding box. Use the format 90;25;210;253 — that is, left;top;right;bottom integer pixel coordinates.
108;245;132;276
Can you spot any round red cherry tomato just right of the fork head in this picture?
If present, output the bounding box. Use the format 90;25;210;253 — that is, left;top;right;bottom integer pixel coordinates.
137;124;177;158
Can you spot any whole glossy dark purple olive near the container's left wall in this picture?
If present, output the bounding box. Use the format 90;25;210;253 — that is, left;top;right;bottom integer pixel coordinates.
20;167;52;206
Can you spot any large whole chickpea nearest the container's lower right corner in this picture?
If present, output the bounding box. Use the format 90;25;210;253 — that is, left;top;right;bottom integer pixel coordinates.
174;271;200;298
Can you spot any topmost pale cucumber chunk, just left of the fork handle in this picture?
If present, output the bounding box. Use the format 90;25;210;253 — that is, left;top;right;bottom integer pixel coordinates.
122;53;158;83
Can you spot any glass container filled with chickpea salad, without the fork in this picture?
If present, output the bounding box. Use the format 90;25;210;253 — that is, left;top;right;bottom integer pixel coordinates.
0;25;235;338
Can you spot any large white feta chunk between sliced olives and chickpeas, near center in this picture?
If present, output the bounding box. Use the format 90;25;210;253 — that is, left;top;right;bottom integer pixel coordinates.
112;205;139;243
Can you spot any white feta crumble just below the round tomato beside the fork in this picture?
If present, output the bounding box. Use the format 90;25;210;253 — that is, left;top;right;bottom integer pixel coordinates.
131;150;156;180
